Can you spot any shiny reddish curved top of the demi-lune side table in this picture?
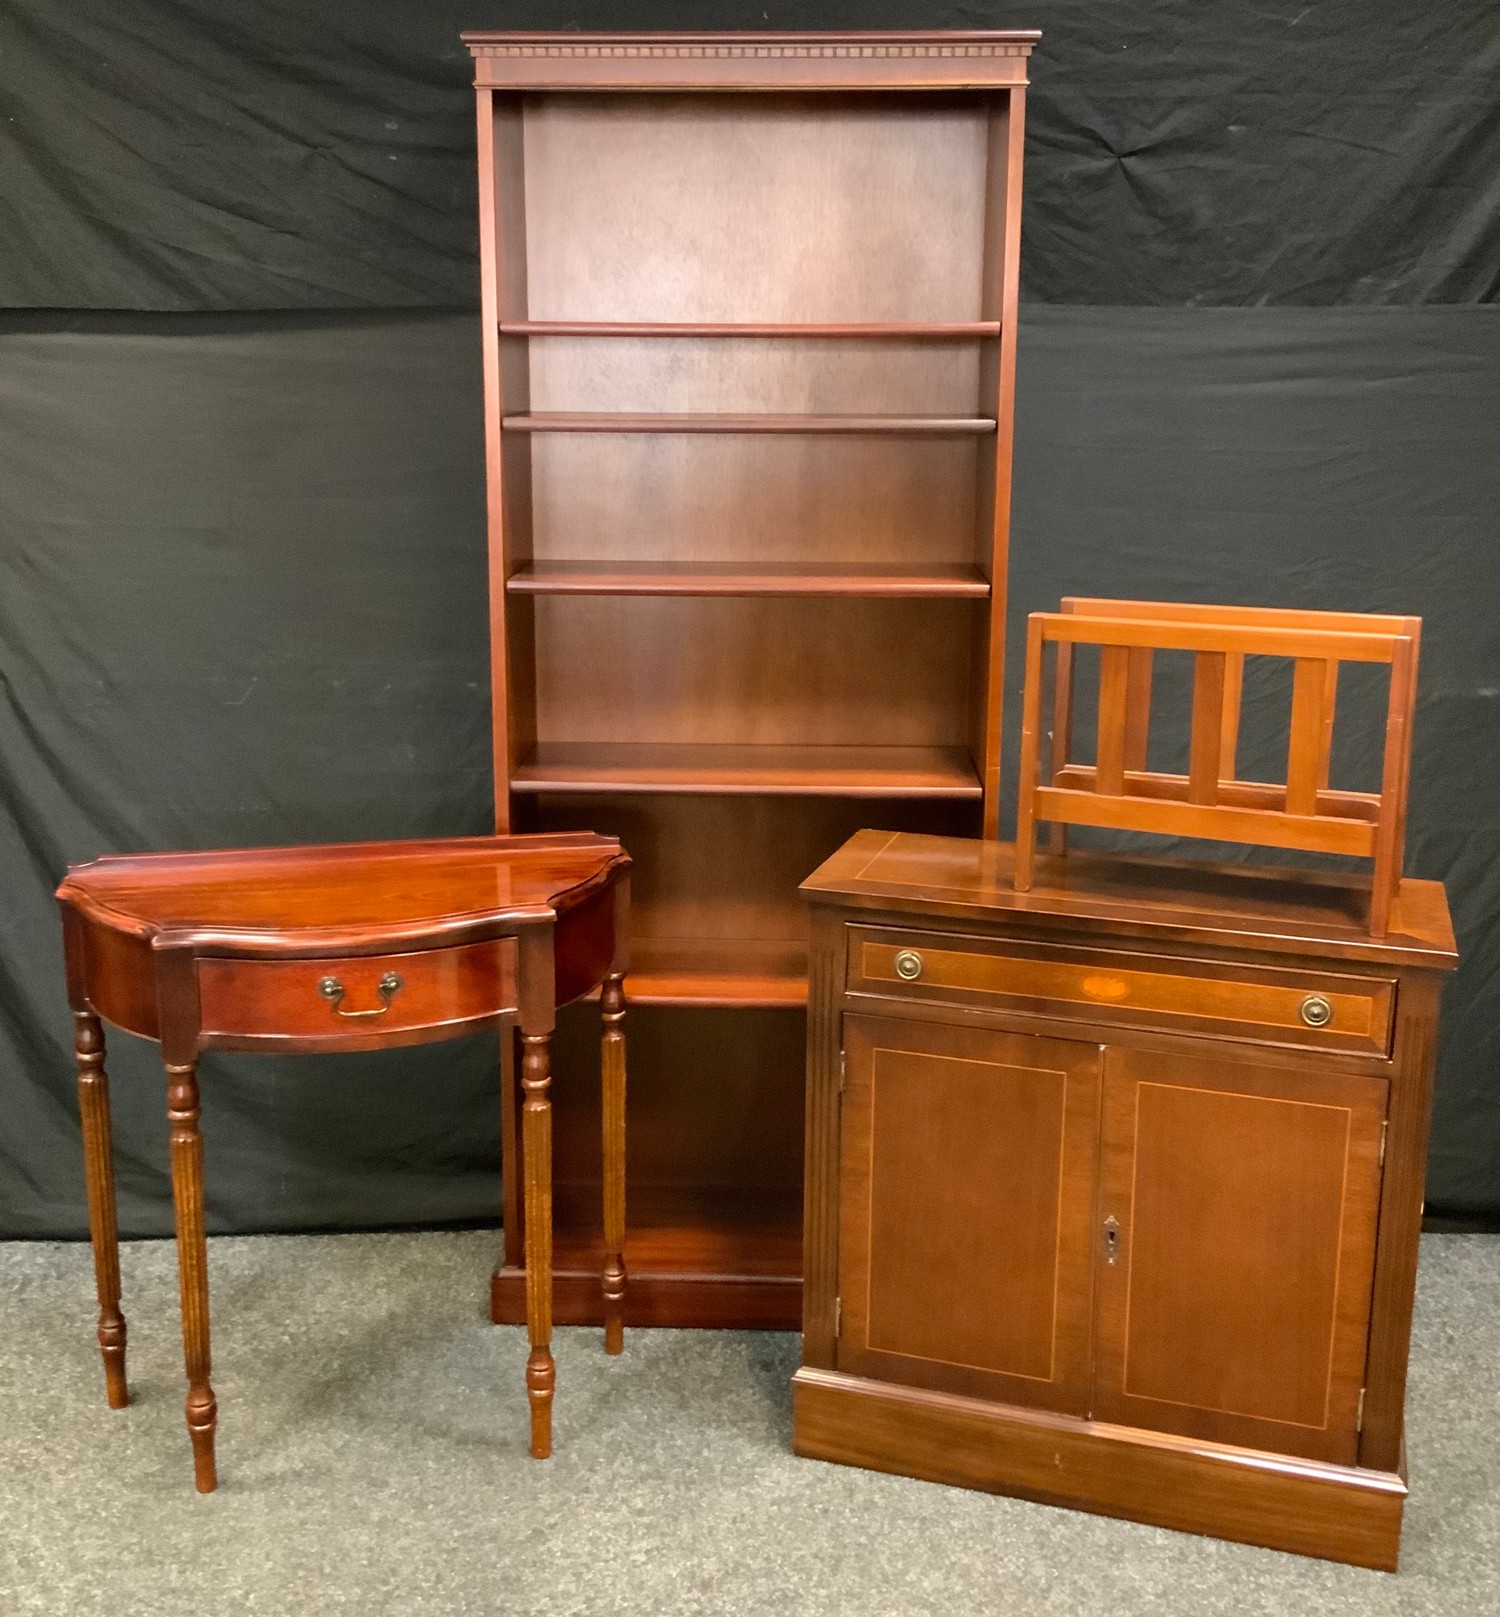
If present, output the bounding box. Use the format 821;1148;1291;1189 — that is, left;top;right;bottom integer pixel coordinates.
57;833;629;949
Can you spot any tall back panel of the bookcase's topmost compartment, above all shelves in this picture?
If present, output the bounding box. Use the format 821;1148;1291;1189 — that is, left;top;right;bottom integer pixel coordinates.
524;94;988;322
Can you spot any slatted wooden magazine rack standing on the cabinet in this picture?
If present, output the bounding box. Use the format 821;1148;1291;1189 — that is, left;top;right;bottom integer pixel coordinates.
1015;598;1421;938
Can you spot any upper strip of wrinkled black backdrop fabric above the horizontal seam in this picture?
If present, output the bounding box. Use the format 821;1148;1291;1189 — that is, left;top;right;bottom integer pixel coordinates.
0;0;1500;310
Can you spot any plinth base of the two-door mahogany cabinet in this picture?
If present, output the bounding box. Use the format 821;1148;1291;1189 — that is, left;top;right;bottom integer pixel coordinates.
792;1368;1406;1572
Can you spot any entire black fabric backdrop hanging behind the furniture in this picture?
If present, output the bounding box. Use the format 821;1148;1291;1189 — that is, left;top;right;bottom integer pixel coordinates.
0;0;1500;1235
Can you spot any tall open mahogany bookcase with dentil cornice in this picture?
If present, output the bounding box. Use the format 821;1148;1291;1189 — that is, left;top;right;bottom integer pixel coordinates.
464;32;1038;1329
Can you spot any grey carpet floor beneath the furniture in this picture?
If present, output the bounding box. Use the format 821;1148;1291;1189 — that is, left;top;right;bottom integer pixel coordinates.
0;1232;1500;1617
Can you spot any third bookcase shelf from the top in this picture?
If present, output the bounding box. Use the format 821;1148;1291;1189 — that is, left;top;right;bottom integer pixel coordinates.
506;561;989;600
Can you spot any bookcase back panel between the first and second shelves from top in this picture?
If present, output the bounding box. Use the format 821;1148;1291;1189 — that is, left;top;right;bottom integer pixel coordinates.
530;336;983;416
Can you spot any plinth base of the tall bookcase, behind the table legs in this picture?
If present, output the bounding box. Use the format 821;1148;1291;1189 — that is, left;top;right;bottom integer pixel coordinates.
490;1264;802;1331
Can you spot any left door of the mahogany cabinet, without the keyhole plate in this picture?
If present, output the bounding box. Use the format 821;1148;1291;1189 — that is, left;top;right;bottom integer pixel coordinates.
837;1015;1099;1413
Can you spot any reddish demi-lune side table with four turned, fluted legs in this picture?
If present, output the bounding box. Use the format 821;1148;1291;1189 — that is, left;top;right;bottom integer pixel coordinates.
57;833;630;1492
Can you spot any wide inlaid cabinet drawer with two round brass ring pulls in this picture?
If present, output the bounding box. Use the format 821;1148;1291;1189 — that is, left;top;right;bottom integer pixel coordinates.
849;927;1397;1054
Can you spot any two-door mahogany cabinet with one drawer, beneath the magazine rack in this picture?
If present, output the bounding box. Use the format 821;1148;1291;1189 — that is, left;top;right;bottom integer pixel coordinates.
794;831;1455;1567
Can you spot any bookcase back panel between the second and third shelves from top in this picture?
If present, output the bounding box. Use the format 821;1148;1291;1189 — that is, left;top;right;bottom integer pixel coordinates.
530;436;988;564
